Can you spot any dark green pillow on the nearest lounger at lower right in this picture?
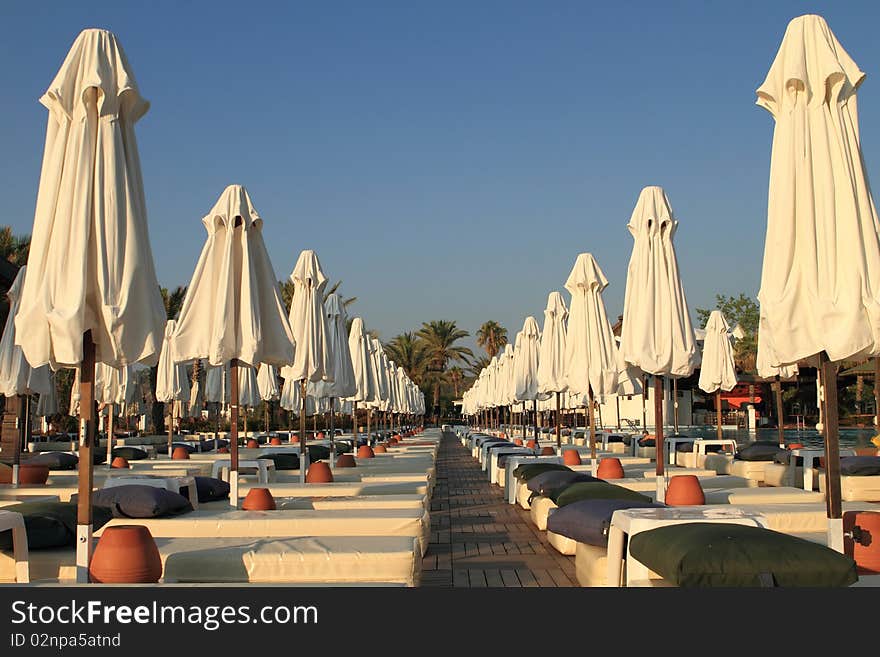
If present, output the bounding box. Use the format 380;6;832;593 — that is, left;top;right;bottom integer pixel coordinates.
629;522;858;587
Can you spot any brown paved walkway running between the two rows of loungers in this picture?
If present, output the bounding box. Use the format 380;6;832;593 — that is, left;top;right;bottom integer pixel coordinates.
422;433;578;588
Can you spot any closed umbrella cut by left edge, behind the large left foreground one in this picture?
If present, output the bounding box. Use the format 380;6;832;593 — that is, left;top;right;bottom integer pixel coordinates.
0;267;55;486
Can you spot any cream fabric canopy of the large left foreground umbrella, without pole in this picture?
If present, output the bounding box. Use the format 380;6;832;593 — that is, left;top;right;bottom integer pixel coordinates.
15;29;165;369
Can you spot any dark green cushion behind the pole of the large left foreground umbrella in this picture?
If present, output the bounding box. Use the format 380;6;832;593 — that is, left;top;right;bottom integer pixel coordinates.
0;502;113;550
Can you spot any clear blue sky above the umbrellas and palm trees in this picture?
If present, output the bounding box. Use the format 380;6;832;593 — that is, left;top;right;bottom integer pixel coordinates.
0;0;880;356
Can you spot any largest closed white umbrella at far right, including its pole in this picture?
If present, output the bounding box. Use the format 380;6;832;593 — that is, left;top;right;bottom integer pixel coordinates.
757;15;880;551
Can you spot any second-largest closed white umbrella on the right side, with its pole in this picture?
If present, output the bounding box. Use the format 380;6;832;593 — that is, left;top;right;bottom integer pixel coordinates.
620;186;700;501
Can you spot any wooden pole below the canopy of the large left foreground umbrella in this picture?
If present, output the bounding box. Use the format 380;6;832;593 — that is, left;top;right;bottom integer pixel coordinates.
76;329;97;584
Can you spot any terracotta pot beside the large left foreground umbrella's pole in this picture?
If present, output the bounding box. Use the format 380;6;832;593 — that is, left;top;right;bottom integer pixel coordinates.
89;525;162;584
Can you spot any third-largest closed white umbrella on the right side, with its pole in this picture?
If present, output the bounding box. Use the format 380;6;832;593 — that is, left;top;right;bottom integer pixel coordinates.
565;253;630;474
